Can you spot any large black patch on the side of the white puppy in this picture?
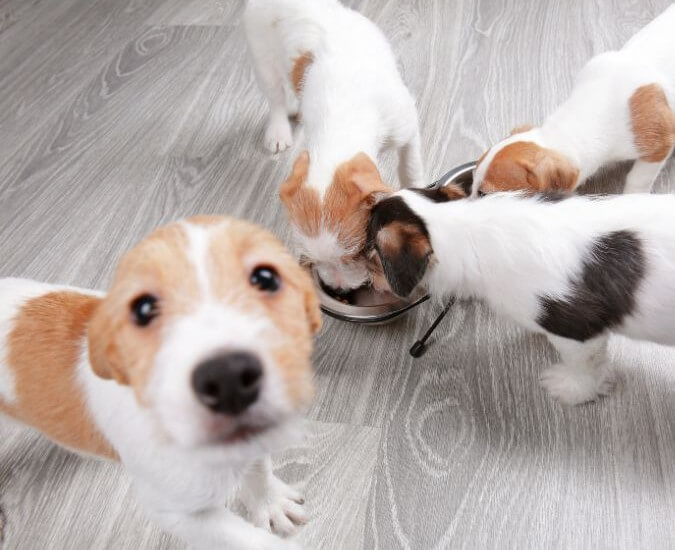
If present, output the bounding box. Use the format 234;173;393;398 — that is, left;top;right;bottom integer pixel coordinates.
537;231;646;342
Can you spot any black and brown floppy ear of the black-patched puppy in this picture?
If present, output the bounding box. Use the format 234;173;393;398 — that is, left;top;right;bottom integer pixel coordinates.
375;221;432;297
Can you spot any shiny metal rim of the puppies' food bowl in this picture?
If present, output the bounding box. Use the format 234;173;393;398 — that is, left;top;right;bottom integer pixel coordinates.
311;161;476;324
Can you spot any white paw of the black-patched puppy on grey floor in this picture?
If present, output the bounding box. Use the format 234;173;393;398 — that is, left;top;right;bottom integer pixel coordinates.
539;364;612;405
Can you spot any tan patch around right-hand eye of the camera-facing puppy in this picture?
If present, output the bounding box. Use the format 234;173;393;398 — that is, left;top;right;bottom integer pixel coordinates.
207;220;322;406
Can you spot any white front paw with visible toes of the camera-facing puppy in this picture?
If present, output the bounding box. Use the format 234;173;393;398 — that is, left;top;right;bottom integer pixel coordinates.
239;457;309;536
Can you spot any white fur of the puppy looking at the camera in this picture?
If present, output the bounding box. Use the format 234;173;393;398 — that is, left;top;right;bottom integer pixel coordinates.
0;224;307;550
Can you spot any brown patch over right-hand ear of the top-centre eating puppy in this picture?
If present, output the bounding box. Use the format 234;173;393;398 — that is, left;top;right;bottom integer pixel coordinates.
323;153;393;254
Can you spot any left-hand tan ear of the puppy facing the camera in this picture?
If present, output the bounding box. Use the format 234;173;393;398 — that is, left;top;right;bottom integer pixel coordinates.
87;299;129;385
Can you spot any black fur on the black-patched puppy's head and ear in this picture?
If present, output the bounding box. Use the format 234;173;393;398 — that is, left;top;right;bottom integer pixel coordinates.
368;197;431;297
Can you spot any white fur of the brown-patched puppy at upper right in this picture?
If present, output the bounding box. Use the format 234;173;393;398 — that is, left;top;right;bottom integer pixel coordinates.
473;5;675;195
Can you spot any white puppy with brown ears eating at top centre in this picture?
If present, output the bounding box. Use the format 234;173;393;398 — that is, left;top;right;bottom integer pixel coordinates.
244;0;425;290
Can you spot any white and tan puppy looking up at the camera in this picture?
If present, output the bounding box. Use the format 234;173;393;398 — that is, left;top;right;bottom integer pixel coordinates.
0;217;321;550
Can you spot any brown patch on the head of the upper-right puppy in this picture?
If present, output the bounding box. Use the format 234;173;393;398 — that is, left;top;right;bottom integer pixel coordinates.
480;141;579;193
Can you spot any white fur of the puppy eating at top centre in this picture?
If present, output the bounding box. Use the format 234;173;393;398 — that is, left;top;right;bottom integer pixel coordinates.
244;0;425;288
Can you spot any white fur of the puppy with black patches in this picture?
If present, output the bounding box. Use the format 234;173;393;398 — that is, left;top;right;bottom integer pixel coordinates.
399;191;675;404
